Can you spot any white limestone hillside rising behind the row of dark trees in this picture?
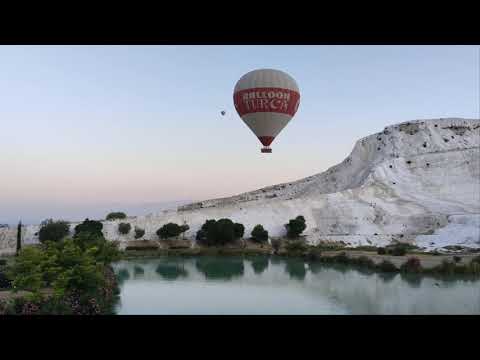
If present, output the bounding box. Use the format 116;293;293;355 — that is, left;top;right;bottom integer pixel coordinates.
0;118;480;251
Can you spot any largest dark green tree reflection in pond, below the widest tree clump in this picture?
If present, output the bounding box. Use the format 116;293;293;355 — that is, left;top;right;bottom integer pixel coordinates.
195;257;244;280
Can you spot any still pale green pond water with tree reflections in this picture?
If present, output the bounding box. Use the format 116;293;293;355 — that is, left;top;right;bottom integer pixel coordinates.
114;256;480;315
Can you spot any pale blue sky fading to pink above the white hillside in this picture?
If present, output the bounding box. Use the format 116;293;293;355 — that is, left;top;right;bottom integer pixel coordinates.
0;46;479;223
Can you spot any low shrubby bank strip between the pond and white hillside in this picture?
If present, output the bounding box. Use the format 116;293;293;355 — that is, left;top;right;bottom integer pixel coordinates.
122;240;480;276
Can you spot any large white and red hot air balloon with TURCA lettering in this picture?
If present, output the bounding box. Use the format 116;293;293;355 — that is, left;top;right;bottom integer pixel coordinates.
233;69;300;153
